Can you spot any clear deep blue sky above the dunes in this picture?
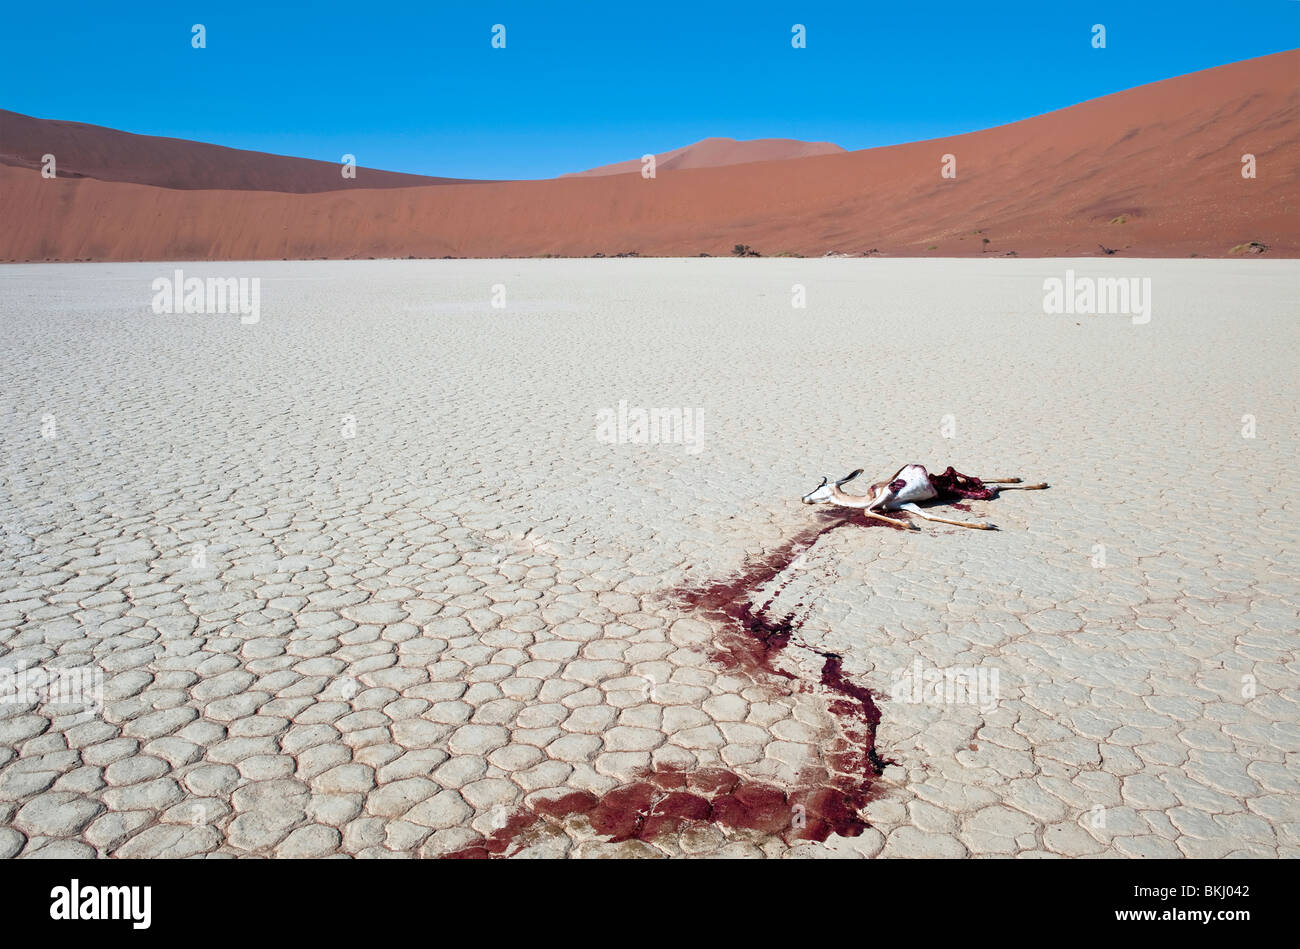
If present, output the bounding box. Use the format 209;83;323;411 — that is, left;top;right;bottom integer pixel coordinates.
0;0;1300;178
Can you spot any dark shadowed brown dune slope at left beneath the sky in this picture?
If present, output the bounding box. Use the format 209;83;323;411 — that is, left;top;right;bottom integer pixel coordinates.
0;109;467;194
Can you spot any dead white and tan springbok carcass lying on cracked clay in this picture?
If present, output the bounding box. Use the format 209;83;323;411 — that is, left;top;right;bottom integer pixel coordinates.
803;464;1047;530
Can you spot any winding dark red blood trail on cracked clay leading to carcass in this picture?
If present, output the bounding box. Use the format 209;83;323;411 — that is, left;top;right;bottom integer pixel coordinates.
447;508;902;859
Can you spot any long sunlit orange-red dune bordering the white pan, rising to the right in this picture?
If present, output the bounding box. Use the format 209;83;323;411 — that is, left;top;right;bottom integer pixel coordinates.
0;51;1300;260
